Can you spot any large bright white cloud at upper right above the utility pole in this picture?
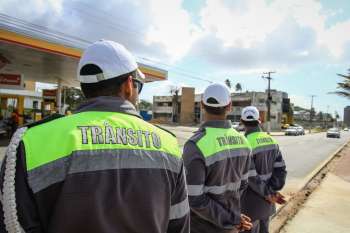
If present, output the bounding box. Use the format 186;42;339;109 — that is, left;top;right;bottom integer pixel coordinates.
193;0;350;68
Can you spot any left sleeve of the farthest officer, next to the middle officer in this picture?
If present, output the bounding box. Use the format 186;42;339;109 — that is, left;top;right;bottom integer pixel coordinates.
248;156;274;198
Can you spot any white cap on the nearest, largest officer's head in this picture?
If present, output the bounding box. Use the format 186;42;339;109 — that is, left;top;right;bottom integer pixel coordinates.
78;40;145;83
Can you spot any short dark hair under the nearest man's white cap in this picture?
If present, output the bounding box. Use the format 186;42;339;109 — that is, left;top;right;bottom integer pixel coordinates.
80;64;136;98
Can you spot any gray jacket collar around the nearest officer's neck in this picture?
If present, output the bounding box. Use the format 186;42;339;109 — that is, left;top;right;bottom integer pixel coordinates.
75;96;141;118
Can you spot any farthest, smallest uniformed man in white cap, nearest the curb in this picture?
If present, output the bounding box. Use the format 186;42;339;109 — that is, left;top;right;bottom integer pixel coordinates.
241;106;287;233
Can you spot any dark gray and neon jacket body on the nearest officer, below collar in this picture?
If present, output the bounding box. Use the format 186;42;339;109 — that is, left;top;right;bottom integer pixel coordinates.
2;111;189;233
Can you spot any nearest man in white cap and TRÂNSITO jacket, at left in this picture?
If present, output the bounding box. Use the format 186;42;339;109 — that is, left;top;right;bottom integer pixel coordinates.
0;40;189;233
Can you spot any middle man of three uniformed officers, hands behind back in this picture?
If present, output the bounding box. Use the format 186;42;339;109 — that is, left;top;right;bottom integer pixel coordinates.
183;84;251;233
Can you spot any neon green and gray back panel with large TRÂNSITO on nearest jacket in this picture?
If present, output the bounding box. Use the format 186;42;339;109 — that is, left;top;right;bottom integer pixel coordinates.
22;112;181;193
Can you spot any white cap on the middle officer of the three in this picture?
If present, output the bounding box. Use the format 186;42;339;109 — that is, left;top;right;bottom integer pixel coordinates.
202;83;231;107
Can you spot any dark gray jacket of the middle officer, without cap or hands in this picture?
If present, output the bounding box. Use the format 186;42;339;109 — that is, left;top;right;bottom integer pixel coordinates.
183;121;251;233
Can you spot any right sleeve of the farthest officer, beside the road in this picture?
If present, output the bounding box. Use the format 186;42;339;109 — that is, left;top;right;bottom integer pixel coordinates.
268;149;287;192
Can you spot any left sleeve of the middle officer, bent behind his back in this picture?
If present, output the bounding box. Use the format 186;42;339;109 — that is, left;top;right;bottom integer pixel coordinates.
183;141;240;229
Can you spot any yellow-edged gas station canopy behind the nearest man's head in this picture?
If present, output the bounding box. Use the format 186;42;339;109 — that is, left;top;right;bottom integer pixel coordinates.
0;28;168;86
